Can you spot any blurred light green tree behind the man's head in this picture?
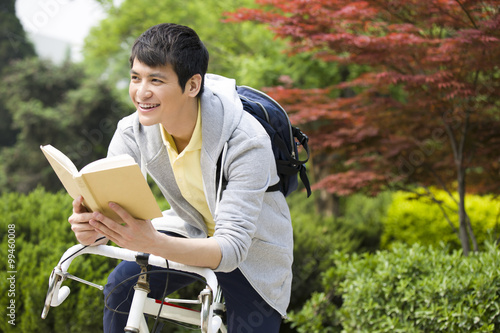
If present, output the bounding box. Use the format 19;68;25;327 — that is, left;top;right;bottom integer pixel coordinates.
84;0;337;98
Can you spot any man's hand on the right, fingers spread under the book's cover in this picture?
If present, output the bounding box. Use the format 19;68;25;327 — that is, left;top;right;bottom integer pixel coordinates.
89;202;161;253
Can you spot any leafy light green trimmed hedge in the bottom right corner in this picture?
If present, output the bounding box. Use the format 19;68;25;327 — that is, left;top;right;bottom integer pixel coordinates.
291;244;500;333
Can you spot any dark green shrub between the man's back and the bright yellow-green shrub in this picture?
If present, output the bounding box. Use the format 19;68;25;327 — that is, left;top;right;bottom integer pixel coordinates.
288;193;390;310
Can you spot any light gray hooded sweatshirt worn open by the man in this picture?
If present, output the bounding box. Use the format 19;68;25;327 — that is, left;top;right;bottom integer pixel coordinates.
108;74;293;316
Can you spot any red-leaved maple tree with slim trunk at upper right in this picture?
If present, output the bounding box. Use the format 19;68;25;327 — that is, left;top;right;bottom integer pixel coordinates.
228;0;500;255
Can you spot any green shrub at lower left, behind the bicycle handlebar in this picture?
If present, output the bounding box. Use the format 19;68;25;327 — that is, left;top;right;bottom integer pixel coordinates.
0;188;116;332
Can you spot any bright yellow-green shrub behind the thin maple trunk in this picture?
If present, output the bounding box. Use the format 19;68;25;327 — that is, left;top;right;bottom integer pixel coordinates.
381;191;499;249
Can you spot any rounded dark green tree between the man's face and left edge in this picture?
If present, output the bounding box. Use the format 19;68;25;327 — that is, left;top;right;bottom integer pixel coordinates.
0;58;131;193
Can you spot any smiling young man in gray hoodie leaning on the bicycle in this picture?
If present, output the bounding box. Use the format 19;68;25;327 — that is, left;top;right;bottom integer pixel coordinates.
69;24;293;332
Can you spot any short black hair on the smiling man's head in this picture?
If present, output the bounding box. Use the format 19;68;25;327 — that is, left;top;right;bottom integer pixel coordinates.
129;23;209;96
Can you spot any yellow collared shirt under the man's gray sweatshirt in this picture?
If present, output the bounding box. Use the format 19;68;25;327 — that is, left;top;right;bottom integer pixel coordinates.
160;101;215;236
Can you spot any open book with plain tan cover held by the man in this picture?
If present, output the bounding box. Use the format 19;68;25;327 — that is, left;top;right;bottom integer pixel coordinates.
40;145;162;221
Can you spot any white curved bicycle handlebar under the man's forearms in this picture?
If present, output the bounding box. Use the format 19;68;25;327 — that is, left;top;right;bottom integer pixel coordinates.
42;244;218;319
